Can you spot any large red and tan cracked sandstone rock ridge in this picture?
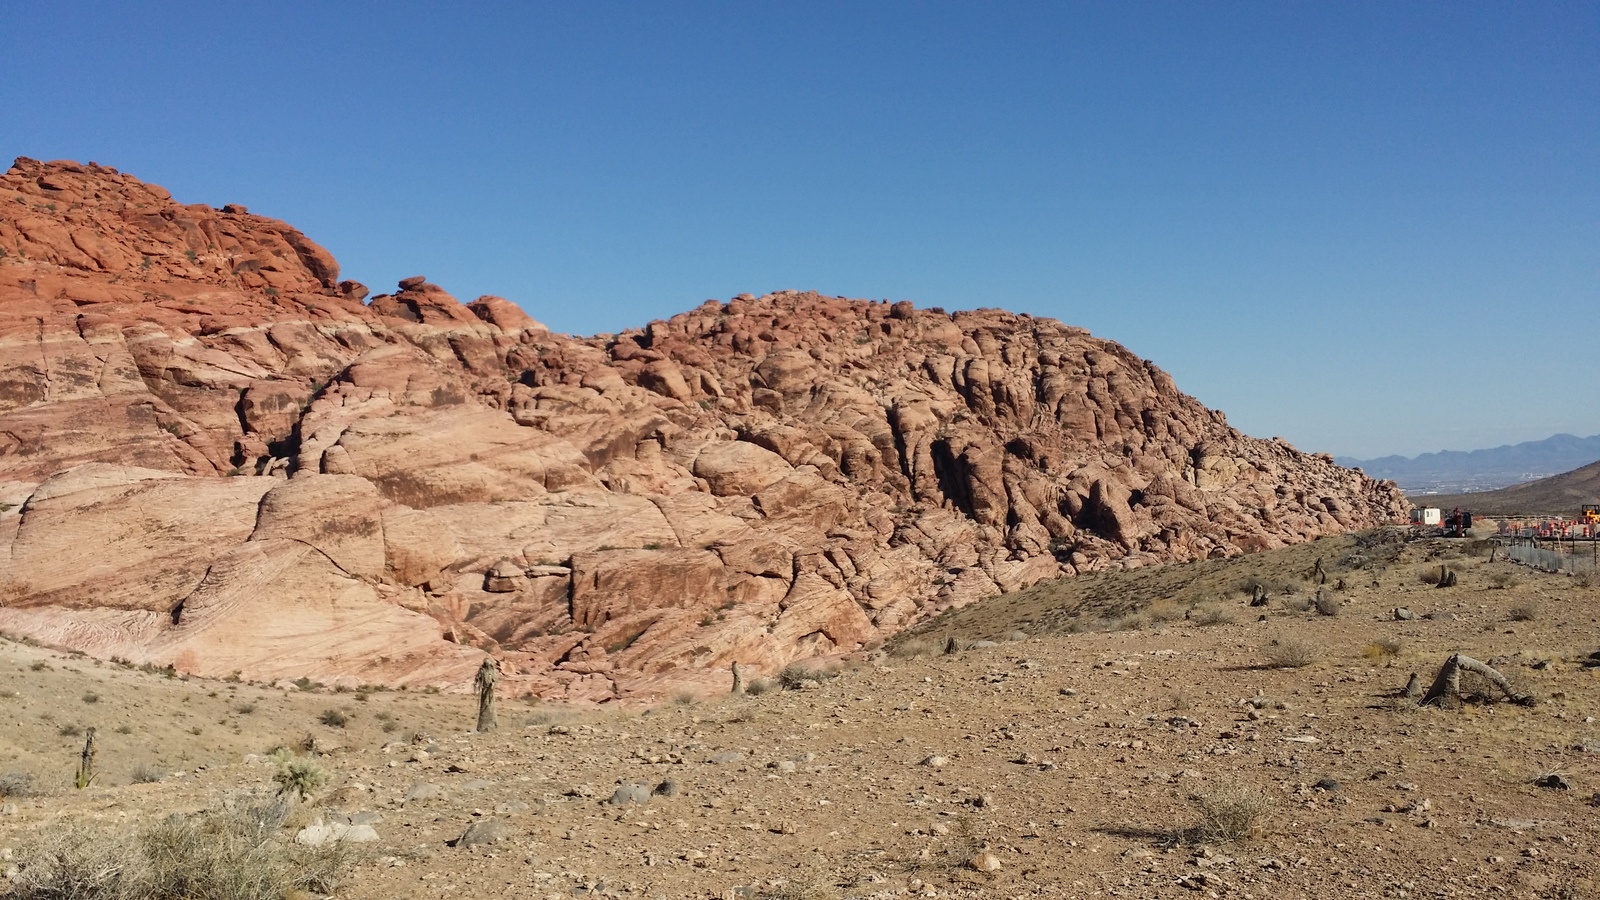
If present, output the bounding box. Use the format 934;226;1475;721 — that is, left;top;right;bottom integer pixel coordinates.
0;159;1406;700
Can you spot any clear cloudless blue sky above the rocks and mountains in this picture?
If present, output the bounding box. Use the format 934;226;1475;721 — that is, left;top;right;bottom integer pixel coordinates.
0;0;1600;456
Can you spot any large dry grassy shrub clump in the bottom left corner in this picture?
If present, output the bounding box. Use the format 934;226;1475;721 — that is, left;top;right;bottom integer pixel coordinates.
10;802;354;900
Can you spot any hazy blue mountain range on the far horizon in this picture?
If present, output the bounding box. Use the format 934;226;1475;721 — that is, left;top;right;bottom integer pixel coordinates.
1334;434;1600;495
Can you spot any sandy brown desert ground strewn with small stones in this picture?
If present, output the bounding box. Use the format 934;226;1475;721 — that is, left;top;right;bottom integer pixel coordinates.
0;530;1600;898
